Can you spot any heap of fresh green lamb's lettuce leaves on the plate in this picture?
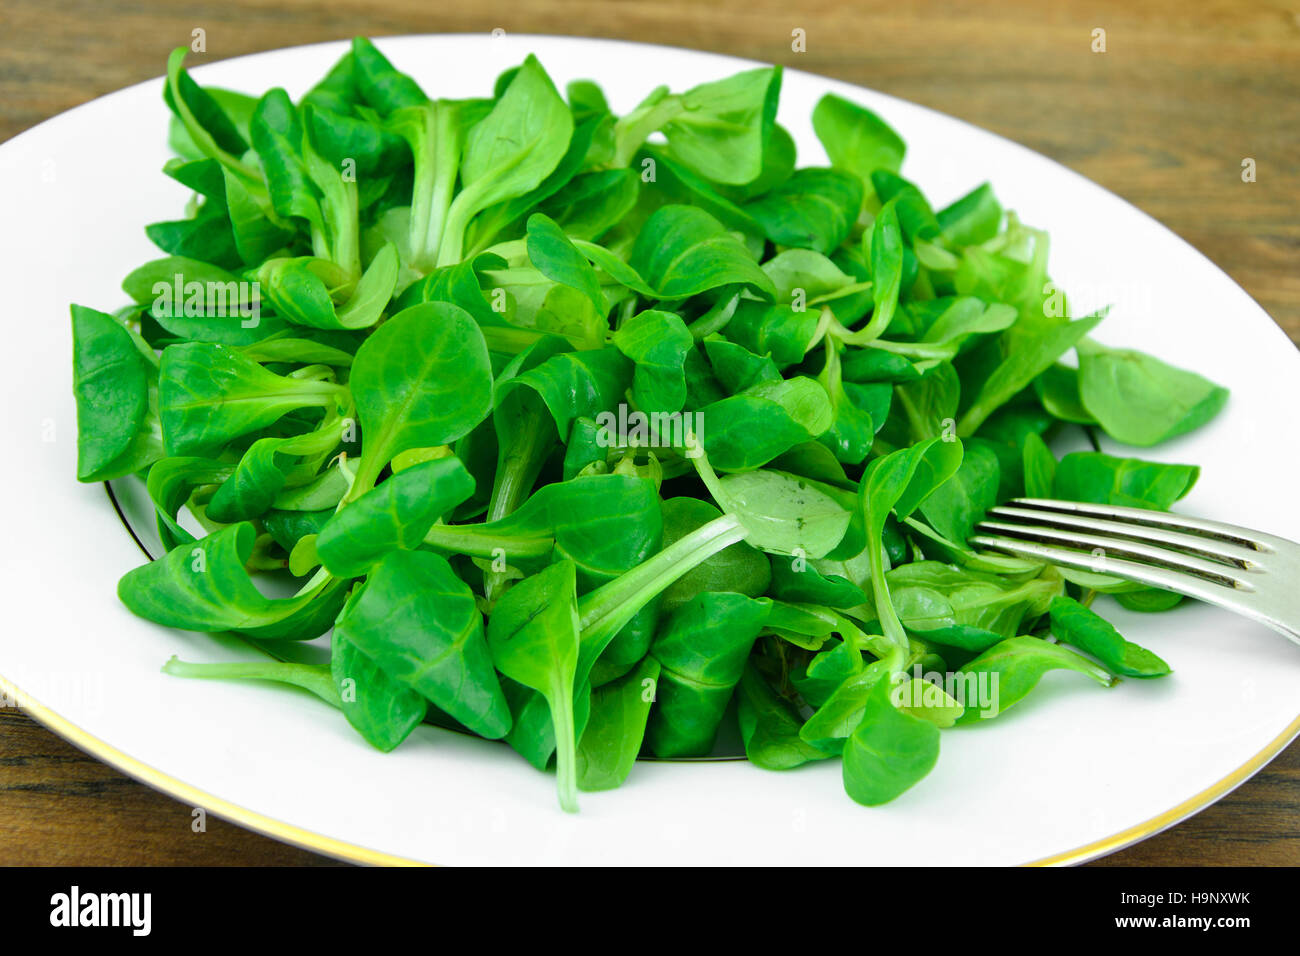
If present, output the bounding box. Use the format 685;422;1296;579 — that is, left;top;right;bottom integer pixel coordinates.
72;39;1227;810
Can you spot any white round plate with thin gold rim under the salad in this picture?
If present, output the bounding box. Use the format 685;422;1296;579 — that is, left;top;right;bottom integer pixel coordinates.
0;36;1300;864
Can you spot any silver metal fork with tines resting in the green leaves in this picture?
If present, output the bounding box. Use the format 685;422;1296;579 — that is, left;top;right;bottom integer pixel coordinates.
970;498;1300;644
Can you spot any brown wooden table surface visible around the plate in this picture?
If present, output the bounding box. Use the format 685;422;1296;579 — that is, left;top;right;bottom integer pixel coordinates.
0;0;1300;865
